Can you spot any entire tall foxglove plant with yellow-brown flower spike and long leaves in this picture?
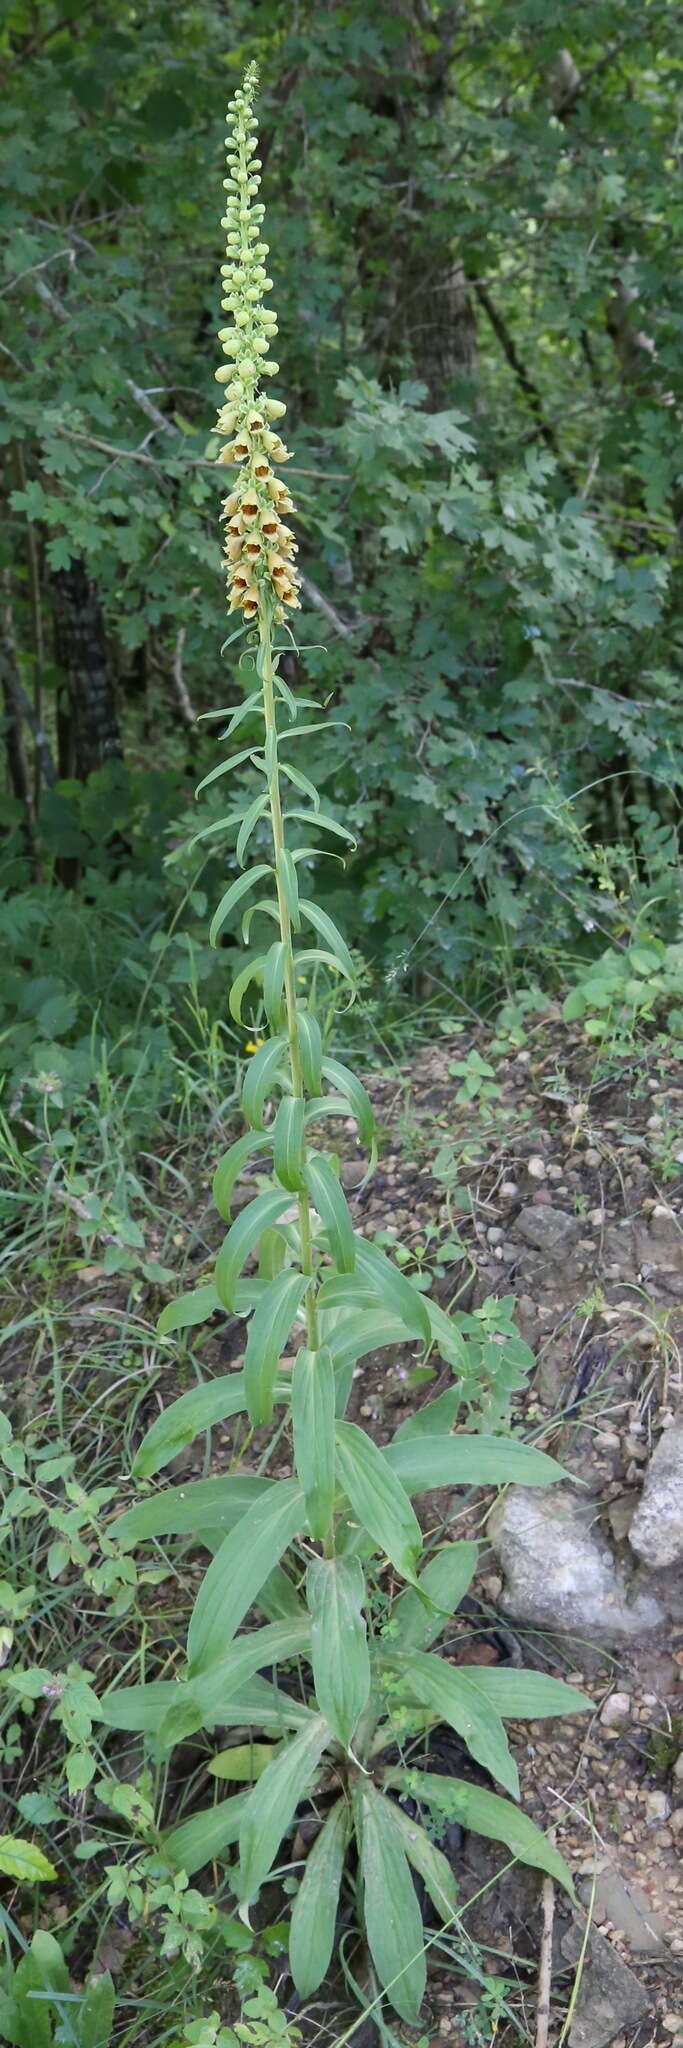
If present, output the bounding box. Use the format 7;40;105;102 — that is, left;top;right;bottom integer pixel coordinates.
103;70;587;2021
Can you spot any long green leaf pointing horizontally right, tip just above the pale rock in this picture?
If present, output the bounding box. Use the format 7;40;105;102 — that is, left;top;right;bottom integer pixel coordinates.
384;1434;566;1493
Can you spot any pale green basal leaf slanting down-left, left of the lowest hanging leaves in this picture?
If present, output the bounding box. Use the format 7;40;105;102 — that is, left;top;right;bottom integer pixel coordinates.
234;1714;330;1903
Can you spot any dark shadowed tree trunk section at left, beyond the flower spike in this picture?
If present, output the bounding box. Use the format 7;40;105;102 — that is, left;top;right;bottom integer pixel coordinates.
51;559;123;780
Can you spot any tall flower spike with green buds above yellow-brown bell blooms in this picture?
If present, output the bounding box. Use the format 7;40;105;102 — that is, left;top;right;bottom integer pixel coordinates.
215;63;299;621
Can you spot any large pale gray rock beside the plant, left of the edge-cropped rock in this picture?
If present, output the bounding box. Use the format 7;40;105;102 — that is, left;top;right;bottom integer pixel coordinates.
488;1487;665;1645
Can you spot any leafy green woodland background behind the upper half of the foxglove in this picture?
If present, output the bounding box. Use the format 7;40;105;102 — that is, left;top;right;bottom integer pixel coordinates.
0;0;683;1094
